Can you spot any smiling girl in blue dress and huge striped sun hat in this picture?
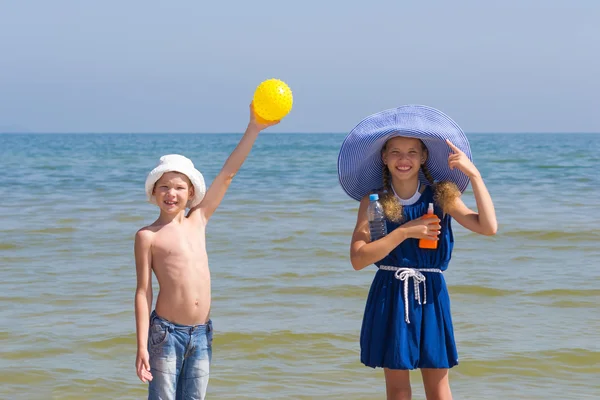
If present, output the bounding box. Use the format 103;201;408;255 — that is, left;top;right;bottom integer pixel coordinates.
338;106;497;400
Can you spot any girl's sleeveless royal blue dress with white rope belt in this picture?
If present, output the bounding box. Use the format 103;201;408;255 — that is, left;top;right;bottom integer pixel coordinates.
360;186;458;369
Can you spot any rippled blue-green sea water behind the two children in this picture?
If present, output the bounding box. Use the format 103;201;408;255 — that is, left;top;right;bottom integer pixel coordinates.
0;133;600;400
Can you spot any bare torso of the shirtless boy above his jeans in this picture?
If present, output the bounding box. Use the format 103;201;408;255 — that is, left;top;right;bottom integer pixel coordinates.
146;218;211;325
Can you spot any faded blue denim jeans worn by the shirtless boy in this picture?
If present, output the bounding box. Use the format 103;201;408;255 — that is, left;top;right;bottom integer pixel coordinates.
148;311;213;400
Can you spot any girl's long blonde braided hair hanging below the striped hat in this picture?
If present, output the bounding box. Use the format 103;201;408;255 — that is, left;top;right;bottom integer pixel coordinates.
379;140;460;222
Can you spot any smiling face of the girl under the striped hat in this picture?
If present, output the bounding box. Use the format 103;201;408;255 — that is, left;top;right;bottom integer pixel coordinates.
381;137;427;181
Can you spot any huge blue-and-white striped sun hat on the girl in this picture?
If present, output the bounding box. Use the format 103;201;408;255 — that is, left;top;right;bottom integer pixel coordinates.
338;105;472;201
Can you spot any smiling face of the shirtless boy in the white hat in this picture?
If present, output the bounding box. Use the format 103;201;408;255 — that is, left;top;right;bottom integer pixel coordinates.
152;172;194;214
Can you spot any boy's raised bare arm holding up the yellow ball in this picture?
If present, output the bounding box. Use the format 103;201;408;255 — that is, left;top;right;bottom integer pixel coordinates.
189;104;279;221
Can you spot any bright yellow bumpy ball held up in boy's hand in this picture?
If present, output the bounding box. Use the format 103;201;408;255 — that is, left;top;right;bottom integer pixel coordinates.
252;79;294;121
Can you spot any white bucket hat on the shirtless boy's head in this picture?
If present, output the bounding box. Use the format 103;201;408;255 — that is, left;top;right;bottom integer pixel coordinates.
146;154;206;208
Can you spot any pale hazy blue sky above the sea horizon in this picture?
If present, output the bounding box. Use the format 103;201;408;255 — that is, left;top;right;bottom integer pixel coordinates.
0;0;600;133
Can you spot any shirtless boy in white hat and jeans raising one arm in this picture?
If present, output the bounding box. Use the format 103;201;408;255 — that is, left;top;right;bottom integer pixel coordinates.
134;104;279;400
